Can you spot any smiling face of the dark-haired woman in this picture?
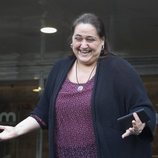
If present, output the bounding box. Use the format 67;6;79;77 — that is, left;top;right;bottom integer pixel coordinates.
71;23;104;65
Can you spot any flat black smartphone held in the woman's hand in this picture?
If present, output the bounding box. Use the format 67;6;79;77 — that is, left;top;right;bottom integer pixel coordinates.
117;109;149;130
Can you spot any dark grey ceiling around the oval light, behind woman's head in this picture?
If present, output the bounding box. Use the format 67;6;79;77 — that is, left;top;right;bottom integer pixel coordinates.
0;0;158;56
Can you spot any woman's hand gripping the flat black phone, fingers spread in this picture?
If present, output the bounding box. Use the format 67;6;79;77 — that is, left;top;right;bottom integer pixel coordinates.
122;112;145;138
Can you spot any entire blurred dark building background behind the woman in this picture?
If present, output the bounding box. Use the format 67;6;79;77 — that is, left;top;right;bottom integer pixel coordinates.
0;0;158;158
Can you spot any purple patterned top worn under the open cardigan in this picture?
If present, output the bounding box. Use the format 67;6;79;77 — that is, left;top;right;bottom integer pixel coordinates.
56;77;97;158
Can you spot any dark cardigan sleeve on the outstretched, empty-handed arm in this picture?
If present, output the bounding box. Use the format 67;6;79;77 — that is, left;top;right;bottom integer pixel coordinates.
31;56;75;128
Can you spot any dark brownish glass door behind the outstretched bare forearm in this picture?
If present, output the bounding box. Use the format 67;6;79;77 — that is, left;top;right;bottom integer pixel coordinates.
0;81;48;158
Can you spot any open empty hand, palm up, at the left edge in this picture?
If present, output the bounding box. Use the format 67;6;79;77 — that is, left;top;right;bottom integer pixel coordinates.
0;125;17;141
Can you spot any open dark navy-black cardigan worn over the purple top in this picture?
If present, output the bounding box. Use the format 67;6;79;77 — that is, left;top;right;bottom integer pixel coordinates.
32;54;156;158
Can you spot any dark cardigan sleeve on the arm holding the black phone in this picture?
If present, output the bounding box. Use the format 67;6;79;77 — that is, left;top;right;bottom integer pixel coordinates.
113;55;156;141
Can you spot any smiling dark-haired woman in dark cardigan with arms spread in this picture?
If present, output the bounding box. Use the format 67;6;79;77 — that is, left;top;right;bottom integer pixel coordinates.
0;13;156;158
